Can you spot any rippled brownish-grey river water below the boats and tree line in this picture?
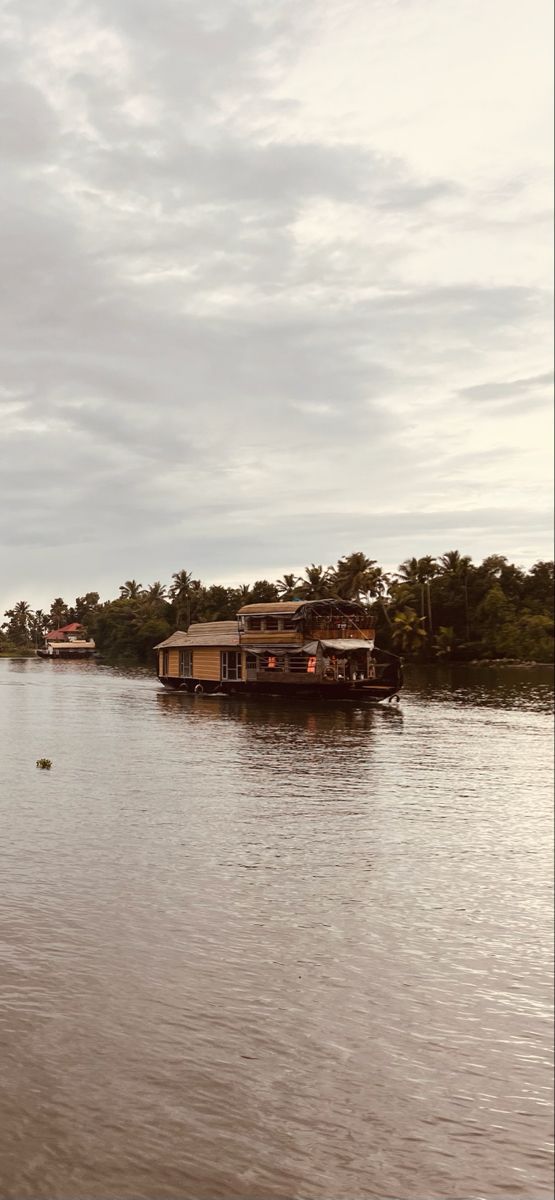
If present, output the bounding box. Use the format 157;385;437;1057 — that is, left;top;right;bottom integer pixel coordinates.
0;660;554;1200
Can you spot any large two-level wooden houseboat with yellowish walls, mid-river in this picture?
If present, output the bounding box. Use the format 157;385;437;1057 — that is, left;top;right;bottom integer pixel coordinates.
155;600;402;701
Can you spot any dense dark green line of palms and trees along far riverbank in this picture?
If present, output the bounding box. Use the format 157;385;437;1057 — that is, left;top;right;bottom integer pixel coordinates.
0;550;554;664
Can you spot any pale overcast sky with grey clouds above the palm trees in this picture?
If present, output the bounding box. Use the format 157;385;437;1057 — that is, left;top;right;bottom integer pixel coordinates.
0;0;553;610
